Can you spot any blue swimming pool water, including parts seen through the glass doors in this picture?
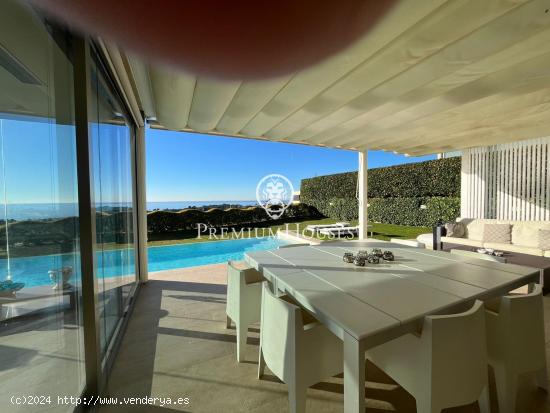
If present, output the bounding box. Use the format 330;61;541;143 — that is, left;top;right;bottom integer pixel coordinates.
0;237;288;287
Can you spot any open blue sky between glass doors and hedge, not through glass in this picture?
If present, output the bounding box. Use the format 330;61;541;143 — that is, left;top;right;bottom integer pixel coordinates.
146;129;434;202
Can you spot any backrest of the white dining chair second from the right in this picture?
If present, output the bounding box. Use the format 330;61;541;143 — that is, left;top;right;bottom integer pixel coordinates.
422;301;487;405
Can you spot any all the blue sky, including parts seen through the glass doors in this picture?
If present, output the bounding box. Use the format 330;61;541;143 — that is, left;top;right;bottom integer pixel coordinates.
0;119;433;204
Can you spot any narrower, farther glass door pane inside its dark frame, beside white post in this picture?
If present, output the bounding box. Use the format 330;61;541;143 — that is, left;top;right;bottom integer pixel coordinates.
90;51;136;353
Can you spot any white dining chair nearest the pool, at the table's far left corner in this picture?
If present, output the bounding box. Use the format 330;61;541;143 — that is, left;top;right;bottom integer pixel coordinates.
225;261;264;363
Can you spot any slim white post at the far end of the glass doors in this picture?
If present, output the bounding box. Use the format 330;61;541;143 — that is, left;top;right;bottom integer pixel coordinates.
136;126;149;282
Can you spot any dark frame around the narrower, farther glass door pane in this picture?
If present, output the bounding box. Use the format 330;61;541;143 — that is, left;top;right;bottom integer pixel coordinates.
73;35;146;400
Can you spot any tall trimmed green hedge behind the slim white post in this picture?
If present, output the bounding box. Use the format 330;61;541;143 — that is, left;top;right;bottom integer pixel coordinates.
300;157;461;226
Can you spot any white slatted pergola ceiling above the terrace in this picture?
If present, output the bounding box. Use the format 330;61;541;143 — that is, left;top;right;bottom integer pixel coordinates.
117;0;550;155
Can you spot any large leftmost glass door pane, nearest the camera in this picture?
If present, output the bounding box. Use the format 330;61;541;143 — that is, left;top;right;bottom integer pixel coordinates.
0;0;85;412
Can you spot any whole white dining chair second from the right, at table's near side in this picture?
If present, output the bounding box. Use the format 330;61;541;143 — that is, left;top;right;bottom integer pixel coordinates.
367;301;490;413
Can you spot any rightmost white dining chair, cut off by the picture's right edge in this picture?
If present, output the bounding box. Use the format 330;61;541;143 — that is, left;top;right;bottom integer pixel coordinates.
486;284;548;413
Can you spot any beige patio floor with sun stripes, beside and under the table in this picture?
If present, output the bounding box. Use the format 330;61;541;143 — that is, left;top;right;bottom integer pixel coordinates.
100;264;550;413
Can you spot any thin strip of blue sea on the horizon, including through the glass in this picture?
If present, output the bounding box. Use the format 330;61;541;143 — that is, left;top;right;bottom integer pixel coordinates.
0;200;257;221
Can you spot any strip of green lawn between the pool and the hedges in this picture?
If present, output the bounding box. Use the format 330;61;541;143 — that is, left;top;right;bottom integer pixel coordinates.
148;218;432;246
